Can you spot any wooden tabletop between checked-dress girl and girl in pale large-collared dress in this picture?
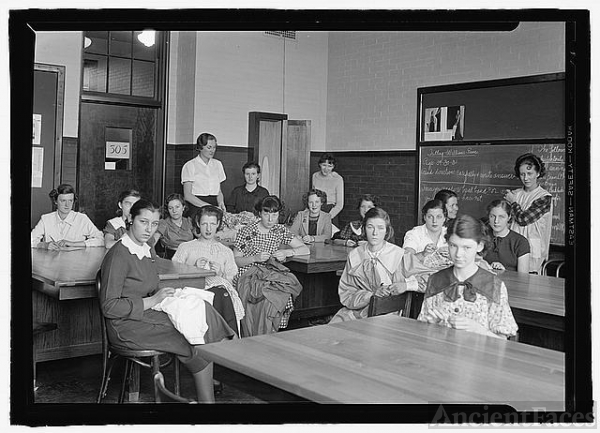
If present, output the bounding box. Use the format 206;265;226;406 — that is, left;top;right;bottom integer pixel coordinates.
285;242;352;274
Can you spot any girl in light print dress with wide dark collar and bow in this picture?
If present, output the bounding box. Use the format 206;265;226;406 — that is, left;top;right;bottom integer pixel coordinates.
418;215;518;338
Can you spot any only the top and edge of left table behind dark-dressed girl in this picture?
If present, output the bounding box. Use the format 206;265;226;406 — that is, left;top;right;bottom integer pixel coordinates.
31;247;214;299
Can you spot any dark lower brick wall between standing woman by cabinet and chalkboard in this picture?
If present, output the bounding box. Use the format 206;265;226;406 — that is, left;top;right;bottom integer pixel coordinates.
310;151;418;245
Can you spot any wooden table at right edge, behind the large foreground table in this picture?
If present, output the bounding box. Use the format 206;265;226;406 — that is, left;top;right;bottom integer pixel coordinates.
498;271;565;350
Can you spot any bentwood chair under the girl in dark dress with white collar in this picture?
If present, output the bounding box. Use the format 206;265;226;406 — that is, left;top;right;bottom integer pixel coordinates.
96;271;180;403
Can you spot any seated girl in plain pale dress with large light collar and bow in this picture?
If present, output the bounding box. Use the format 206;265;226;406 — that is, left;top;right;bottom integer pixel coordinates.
329;207;423;323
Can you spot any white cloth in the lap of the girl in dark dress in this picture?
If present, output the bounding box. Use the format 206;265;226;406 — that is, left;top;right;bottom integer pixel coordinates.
152;287;215;345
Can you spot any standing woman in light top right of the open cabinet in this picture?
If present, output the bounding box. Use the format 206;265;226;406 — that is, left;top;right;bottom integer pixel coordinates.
312;153;344;227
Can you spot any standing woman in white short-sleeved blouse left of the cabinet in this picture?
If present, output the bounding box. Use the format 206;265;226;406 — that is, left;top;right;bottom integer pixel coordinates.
181;132;227;218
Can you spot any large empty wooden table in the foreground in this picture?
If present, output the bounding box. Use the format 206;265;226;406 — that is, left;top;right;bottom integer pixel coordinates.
200;315;565;411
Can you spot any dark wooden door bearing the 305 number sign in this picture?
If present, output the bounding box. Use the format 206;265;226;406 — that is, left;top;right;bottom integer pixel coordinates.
79;102;162;229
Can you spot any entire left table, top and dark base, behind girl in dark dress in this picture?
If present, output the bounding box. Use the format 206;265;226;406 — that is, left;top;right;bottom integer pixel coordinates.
31;247;214;361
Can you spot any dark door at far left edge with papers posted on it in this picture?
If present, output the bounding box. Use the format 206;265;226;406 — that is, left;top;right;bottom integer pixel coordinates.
31;64;65;228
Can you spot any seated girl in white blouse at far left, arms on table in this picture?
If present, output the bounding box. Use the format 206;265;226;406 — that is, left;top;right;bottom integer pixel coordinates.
31;183;104;250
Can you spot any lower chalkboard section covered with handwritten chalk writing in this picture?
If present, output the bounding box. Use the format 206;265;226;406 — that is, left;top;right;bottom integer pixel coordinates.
419;142;565;245
